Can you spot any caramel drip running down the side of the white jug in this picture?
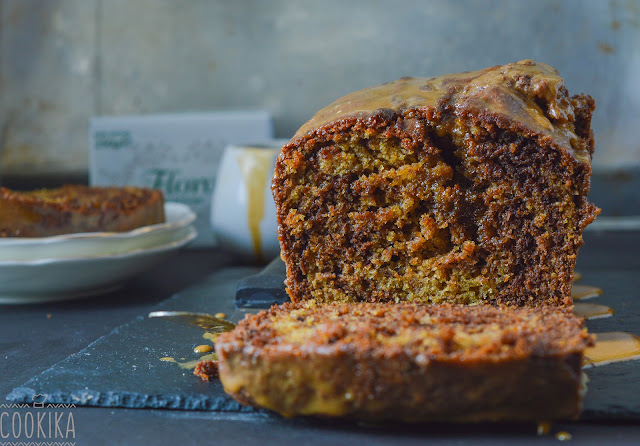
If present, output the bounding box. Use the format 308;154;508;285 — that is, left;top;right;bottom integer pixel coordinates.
238;147;279;261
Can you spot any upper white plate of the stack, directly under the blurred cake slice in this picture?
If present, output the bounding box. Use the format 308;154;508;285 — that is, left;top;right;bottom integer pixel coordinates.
0;202;196;262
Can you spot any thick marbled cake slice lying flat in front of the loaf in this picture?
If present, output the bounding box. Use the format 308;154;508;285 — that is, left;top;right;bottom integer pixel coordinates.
216;300;593;422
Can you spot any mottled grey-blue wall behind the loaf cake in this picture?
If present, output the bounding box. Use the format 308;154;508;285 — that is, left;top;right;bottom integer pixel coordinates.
0;0;640;174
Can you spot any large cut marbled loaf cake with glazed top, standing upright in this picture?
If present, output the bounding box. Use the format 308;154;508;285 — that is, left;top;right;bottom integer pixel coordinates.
272;60;599;306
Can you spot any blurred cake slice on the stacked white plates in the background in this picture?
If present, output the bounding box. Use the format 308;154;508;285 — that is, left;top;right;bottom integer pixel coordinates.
0;185;165;237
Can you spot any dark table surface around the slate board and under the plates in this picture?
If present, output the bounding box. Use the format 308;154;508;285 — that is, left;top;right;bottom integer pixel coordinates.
0;232;640;445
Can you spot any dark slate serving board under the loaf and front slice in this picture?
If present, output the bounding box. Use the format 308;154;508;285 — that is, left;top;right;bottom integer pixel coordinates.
7;265;640;420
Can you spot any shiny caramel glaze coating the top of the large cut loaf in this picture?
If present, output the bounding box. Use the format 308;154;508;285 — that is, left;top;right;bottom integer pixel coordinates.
293;60;593;163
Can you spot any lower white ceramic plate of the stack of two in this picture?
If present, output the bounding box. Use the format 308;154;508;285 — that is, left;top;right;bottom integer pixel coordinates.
0;226;197;304
